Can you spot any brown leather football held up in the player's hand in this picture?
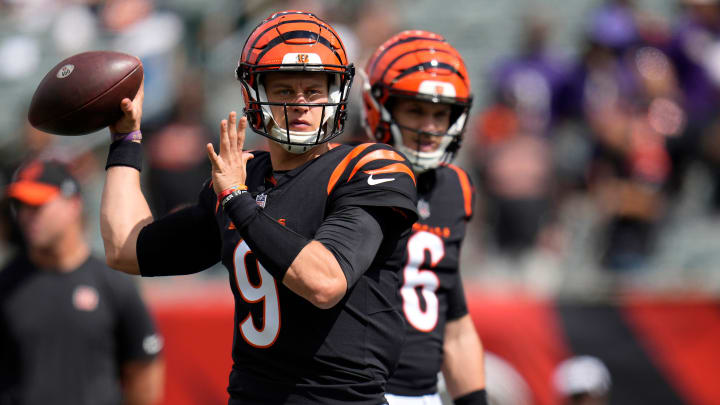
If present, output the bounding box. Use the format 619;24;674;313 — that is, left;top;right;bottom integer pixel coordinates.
28;51;143;135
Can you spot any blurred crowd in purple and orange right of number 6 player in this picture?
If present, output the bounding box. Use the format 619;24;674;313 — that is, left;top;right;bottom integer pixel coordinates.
468;0;720;296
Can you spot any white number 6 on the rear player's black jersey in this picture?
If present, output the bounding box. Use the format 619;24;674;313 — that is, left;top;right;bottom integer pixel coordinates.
400;232;445;332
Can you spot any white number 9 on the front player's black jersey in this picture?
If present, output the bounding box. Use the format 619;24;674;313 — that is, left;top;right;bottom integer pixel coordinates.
233;241;280;349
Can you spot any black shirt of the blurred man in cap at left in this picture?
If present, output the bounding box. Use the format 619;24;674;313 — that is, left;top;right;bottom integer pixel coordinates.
0;256;161;405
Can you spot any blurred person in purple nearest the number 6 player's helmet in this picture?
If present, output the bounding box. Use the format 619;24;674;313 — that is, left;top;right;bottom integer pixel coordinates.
472;7;570;259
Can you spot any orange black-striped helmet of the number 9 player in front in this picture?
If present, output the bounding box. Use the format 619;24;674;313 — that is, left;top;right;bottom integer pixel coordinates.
236;10;355;153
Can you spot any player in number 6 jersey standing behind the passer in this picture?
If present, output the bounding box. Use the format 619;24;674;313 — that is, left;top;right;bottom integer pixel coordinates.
363;31;486;405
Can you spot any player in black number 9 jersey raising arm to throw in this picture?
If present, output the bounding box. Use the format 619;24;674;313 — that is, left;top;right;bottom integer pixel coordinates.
101;11;417;405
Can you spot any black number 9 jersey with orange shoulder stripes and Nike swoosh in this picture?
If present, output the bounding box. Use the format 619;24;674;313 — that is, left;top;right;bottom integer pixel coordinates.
138;144;416;404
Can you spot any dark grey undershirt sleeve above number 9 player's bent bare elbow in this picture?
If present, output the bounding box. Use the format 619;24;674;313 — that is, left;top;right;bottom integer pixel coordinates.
315;206;383;289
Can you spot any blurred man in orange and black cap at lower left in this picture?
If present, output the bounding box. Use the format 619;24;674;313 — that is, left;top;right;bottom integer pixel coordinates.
0;160;164;405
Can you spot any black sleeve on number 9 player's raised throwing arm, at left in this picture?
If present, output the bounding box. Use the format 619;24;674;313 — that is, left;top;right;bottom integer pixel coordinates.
136;205;222;276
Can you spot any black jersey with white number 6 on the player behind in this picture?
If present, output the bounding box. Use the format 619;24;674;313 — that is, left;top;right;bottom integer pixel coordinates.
387;165;474;396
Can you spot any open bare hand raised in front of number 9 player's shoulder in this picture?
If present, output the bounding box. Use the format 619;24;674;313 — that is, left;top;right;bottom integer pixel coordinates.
206;111;254;195
